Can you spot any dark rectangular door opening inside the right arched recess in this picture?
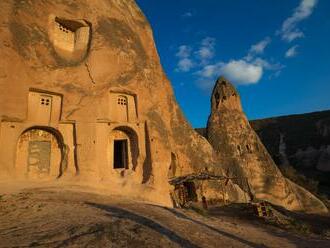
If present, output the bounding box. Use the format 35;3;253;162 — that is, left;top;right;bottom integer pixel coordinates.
113;139;128;169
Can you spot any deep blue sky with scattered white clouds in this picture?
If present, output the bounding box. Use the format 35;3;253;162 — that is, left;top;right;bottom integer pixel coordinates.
137;0;330;127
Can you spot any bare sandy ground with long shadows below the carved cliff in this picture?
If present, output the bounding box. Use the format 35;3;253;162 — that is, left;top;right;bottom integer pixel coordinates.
0;185;330;248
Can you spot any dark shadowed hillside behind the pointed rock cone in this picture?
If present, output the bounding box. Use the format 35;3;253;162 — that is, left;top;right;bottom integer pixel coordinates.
196;110;330;196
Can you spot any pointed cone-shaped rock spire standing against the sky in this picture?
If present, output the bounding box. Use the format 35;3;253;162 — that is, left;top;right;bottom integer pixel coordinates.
206;77;326;212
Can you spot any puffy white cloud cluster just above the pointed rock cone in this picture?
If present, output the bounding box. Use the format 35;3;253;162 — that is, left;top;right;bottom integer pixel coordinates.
176;37;284;90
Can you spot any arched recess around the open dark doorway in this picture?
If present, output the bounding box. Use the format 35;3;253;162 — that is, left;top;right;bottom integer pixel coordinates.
110;126;139;170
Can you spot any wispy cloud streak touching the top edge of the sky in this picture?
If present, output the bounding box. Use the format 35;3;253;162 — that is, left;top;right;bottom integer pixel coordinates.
278;0;318;42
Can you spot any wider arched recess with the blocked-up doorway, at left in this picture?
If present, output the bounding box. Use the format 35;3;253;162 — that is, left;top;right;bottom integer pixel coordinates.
15;127;66;179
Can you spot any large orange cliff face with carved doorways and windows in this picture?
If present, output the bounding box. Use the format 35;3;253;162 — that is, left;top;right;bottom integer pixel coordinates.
0;0;242;205
